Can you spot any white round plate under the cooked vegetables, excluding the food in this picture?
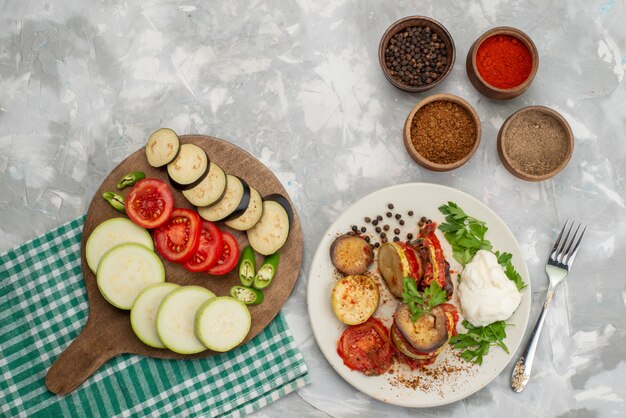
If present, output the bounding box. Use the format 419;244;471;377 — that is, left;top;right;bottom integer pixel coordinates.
307;183;531;408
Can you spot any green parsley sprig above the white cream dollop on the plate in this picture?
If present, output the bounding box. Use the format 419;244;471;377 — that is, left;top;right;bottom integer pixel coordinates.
439;202;526;290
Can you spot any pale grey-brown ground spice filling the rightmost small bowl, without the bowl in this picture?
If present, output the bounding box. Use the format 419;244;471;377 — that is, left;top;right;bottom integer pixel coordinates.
503;110;569;176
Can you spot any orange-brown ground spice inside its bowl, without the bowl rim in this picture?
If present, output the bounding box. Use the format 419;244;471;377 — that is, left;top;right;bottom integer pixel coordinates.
411;101;476;164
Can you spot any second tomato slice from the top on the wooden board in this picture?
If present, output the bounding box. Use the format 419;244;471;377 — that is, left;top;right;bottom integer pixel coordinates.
154;208;202;263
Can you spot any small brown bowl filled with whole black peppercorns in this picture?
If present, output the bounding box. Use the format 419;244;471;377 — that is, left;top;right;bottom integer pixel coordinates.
378;16;456;93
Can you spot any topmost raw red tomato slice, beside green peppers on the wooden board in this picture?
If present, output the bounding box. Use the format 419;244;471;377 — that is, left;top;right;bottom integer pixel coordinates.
126;178;174;229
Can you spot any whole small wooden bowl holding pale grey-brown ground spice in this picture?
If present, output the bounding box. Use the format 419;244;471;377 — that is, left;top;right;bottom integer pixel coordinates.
498;106;574;181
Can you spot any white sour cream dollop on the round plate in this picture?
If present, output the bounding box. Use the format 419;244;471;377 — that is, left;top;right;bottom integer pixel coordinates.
457;250;522;327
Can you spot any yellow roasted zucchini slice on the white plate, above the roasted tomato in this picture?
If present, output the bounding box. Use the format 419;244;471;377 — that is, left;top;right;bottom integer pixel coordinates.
331;275;380;325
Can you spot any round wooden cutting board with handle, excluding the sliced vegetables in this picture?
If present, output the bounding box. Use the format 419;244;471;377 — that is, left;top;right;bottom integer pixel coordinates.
46;135;302;395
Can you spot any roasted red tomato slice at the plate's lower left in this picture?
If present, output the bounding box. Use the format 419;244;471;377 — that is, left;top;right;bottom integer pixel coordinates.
337;317;393;376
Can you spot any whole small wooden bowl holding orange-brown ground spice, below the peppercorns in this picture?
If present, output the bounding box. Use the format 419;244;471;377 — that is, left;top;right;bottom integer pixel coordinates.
404;94;482;171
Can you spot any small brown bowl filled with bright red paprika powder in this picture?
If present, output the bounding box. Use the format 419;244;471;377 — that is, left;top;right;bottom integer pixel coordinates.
465;26;539;100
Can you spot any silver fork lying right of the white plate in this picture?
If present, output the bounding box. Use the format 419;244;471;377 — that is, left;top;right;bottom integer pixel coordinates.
511;220;587;392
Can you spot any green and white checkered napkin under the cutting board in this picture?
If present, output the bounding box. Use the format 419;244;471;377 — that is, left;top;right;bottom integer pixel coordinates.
0;218;309;417
